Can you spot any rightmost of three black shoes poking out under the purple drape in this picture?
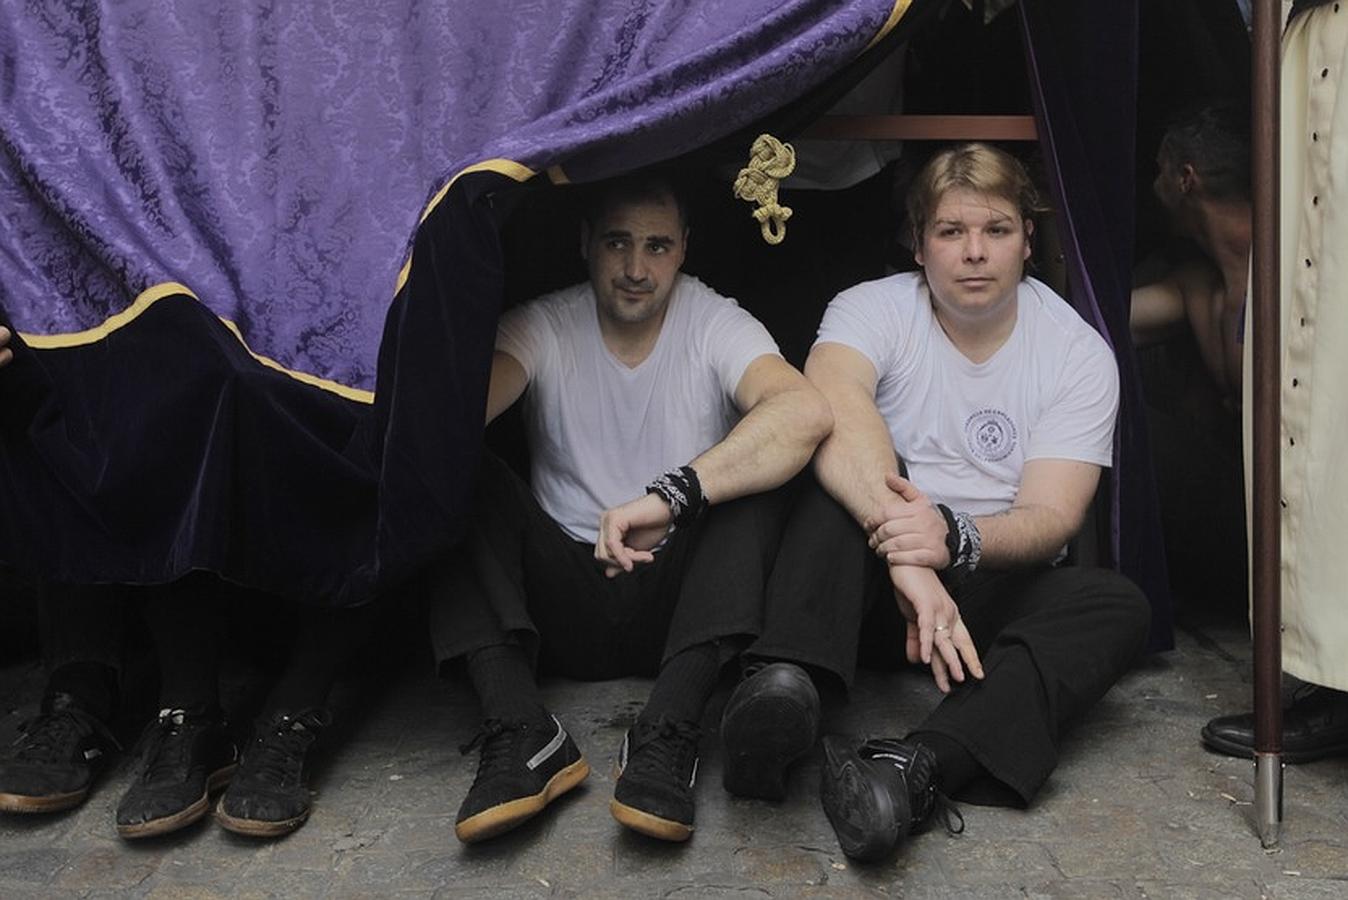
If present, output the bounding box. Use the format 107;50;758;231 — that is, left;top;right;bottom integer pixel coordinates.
216;709;332;838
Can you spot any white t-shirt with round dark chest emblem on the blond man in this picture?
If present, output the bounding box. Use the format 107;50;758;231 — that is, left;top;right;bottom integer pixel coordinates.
816;272;1119;516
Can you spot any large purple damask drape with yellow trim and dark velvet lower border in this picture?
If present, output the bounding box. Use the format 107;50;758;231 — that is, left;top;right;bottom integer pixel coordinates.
0;0;905;604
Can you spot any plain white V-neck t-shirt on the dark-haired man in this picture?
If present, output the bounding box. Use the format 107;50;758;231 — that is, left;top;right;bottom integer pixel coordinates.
496;275;780;543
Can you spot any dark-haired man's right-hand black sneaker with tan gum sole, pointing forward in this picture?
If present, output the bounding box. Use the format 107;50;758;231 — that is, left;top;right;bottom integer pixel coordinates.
608;717;701;841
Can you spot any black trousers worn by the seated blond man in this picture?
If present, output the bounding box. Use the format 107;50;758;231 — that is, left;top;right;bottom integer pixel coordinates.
748;482;1150;803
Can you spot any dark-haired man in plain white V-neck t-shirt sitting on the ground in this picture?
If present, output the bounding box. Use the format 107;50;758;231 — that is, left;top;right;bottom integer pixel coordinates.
433;175;832;842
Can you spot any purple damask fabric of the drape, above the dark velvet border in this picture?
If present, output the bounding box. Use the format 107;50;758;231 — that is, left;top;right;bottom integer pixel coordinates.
0;0;905;389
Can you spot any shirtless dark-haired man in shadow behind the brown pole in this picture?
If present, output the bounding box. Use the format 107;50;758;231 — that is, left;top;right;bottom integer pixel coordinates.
1130;100;1251;609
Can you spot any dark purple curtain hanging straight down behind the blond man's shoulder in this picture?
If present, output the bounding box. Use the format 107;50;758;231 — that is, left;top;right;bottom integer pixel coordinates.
1019;0;1174;649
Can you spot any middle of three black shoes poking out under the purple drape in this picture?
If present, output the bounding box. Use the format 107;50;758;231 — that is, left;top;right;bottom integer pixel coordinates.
117;709;239;838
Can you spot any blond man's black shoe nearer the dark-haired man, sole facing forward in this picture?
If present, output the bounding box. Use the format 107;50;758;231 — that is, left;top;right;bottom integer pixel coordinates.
721;663;820;800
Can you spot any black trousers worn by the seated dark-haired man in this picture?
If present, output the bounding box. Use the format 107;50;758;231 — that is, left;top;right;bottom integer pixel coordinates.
419;454;785;680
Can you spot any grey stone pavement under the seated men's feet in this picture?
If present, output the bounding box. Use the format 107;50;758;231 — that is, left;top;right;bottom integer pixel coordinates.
0;611;1348;900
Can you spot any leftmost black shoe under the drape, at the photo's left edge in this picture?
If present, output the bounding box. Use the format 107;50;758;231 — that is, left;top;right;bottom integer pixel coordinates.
0;694;117;812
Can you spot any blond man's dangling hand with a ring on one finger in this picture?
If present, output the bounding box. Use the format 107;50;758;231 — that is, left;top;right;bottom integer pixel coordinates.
890;566;983;694
